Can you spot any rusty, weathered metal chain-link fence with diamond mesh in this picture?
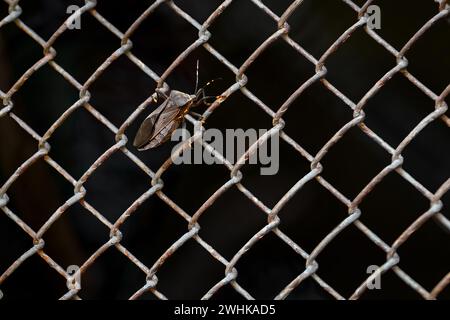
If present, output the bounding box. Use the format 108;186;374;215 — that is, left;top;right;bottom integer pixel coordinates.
0;0;450;299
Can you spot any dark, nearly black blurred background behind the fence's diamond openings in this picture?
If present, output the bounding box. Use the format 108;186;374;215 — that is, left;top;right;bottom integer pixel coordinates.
0;0;450;299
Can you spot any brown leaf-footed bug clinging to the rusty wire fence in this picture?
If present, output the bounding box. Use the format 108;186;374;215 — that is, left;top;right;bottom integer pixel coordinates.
133;63;215;151
